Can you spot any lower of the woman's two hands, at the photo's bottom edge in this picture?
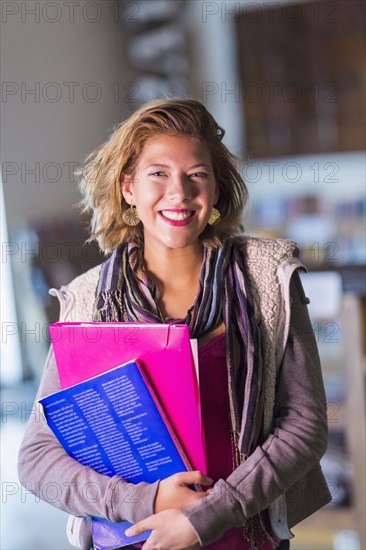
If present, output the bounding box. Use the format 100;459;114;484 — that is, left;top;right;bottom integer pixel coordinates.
125;510;201;550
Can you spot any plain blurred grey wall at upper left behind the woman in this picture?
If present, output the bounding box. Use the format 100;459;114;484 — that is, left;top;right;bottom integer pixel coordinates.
1;0;133;226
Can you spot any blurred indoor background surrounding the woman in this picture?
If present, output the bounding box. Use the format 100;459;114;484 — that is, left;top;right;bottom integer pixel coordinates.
0;0;366;550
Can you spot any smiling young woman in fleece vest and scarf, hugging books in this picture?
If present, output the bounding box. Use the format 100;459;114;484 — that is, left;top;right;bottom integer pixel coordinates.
19;99;330;550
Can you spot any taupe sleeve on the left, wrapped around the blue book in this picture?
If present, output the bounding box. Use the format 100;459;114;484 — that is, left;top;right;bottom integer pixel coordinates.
18;348;159;523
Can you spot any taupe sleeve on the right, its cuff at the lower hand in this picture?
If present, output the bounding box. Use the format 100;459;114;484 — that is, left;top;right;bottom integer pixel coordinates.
183;272;328;546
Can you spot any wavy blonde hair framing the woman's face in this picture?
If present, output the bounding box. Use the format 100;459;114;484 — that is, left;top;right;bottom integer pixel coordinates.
79;99;248;254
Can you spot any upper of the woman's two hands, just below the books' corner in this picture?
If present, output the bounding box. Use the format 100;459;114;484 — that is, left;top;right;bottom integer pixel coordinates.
154;470;213;513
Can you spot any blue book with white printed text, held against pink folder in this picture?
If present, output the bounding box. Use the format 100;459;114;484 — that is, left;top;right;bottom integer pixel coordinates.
39;360;191;550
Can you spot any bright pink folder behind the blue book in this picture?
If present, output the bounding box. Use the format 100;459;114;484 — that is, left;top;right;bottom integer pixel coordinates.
49;323;207;474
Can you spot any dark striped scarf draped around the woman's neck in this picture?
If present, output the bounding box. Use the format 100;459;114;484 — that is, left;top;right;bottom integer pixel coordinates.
94;240;263;460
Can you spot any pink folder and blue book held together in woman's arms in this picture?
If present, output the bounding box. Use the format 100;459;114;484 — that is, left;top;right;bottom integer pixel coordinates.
40;323;206;550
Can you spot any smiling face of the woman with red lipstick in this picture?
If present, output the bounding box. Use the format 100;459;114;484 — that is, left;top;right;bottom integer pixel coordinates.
122;134;218;254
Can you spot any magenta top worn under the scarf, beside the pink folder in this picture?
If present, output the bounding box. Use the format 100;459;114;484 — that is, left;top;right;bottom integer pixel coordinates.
198;333;273;550
